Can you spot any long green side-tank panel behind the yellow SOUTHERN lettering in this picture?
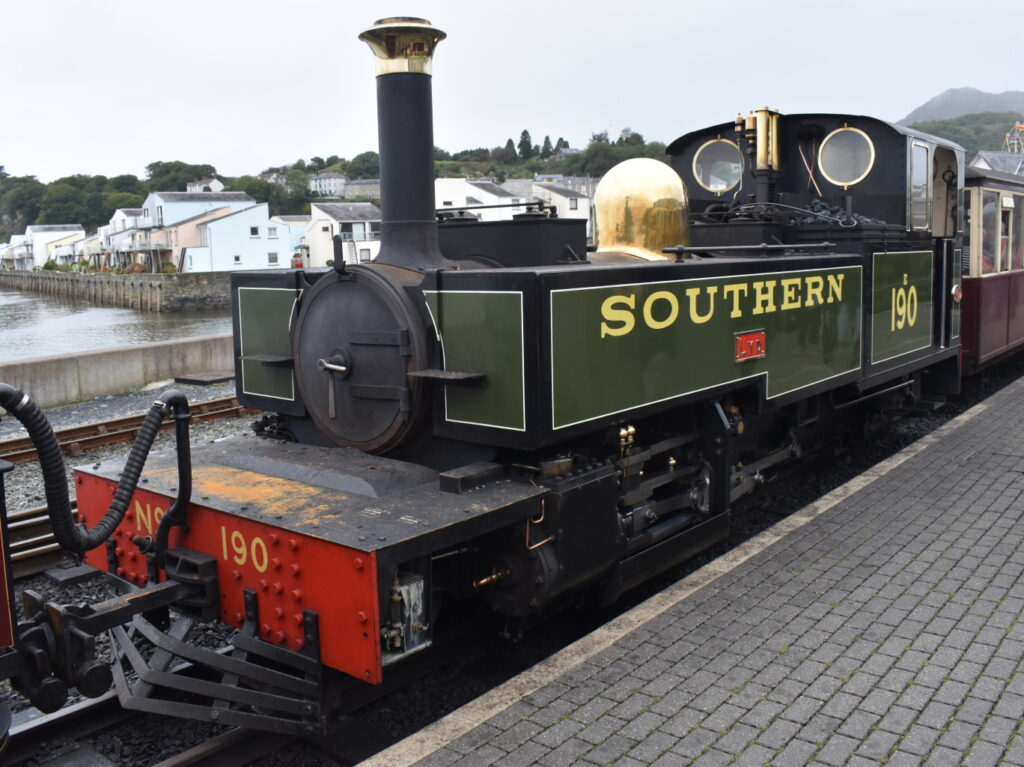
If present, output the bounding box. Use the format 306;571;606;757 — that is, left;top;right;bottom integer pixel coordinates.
551;266;862;429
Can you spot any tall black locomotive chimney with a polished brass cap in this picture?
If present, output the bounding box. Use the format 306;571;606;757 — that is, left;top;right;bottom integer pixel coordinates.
359;16;450;271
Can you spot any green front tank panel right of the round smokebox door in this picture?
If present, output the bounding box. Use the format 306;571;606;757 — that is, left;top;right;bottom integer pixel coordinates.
424;291;526;431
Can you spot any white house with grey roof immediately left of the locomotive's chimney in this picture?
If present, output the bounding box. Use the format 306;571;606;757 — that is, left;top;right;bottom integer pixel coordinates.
303;203;381;266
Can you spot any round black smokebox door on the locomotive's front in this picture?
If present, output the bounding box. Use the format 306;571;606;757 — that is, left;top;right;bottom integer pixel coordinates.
294;266;427;453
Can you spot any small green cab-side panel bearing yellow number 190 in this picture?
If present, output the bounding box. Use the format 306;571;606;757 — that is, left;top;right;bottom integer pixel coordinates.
871;251;934;365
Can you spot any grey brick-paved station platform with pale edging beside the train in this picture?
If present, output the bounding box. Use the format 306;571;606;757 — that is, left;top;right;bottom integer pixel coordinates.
362;379;1024;767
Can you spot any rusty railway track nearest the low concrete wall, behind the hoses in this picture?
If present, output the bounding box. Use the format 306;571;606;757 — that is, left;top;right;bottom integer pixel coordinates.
0;396;255;464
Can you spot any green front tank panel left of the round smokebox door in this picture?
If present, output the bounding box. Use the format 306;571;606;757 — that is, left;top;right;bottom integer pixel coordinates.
238;288;300;401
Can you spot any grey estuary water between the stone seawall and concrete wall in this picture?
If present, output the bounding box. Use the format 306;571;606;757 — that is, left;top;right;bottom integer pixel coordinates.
0;288;231;363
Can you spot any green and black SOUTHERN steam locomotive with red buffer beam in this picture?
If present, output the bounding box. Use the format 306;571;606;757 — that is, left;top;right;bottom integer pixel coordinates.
0;13;983;733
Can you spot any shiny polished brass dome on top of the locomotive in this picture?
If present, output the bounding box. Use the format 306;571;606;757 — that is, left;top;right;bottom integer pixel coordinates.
593;158;690;261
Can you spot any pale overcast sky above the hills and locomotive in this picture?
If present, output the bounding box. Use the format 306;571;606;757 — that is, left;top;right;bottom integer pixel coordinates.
0;0;1024;181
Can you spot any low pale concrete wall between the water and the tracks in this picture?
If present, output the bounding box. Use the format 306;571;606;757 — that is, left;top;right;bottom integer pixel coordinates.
0;333;234;408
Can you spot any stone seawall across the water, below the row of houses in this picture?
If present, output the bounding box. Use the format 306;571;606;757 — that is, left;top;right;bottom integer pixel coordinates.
0;271;231;312
